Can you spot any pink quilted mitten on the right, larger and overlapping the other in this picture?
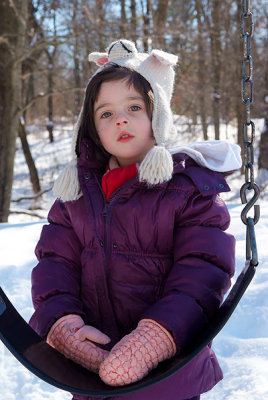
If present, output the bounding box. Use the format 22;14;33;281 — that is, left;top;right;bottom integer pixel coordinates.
99;319;176;386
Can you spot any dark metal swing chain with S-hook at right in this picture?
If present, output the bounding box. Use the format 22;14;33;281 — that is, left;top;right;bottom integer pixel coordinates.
240;0;260;266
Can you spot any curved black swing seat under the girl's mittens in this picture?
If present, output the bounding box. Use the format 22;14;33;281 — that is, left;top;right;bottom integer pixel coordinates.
0;262;256;398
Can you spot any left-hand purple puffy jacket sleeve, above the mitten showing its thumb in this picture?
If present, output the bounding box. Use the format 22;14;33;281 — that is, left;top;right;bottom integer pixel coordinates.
30;200;84;337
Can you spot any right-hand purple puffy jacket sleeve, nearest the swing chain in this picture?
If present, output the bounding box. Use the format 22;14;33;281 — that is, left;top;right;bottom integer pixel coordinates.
142;193;235;352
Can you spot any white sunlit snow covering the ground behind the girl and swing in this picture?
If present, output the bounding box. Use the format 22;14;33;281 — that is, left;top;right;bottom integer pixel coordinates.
0;120;268;400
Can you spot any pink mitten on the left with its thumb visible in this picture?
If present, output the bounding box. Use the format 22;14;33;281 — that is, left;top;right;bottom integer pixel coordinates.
47;314;110;373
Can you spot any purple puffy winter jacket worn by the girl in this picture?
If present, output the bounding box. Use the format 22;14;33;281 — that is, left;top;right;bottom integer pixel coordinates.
30;141;235;400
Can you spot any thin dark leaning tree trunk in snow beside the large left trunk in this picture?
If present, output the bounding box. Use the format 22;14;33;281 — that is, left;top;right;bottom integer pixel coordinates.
18;121;41;193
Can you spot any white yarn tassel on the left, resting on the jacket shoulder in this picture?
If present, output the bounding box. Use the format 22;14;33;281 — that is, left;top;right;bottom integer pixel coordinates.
53;160;82;202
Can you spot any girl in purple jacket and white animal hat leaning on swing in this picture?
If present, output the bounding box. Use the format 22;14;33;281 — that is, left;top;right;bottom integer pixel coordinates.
30;40;240;400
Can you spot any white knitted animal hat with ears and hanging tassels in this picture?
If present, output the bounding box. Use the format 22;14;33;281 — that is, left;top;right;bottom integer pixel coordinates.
53;39;178;201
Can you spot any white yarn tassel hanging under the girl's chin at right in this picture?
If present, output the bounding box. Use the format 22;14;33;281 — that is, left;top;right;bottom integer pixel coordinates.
139;146;173;185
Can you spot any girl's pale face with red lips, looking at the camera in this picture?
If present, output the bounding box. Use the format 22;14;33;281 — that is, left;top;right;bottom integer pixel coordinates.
94;80;155;167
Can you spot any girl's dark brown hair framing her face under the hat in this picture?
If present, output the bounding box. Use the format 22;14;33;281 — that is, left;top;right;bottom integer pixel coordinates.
76;63;154;156
